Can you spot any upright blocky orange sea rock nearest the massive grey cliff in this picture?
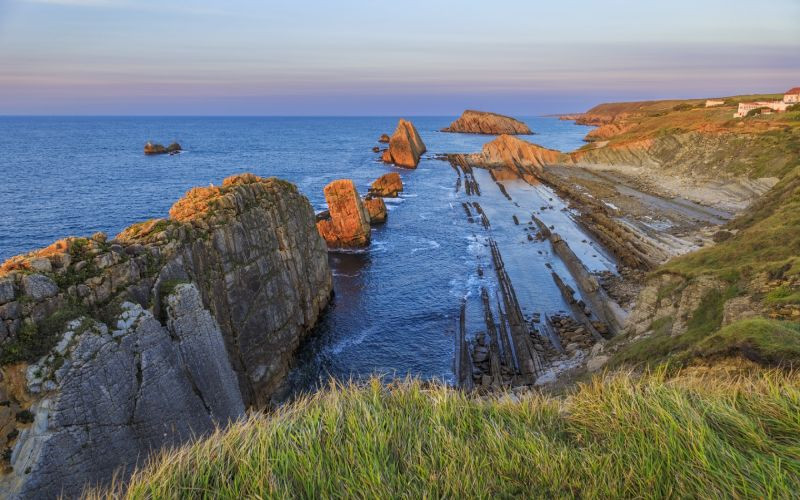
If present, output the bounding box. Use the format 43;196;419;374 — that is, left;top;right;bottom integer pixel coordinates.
317;179;370;248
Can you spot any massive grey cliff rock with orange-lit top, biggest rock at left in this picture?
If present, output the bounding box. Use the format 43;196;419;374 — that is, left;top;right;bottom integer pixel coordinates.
0;174;332;498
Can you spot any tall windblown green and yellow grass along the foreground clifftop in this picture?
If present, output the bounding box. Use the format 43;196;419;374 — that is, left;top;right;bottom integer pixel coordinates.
90;372;800;499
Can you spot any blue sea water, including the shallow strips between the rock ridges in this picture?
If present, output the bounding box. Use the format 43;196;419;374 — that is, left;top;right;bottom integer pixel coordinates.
0;117;610;387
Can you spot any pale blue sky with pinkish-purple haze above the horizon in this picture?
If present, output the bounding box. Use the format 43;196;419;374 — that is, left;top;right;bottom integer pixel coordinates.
0;0;800;116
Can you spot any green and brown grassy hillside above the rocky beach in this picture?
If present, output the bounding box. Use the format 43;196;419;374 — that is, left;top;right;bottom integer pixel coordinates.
588;95;800;365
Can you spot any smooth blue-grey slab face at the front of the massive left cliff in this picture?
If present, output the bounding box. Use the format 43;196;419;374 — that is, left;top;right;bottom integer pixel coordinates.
0;285;244;498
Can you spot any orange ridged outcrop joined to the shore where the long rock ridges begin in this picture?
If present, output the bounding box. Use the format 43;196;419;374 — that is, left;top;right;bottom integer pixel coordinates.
464;135;566;177
